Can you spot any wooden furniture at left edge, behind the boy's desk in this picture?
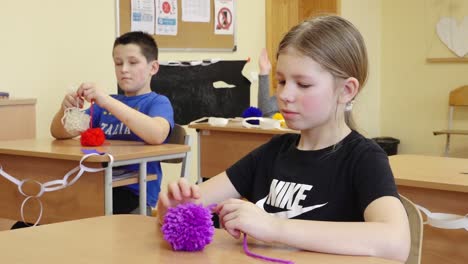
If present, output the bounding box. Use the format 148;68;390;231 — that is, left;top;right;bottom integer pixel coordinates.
0;99;36;140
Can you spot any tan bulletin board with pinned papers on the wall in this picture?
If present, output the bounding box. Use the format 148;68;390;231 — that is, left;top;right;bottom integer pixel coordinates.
117;0;237;51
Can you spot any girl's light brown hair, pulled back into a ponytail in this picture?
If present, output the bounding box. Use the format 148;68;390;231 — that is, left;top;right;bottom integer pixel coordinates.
276;15;368;129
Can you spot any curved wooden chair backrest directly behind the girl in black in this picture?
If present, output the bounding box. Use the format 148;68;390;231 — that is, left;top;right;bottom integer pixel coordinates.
400;195;424;264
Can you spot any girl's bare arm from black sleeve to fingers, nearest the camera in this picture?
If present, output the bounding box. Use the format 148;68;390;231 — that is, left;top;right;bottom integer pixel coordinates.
218;196;410;262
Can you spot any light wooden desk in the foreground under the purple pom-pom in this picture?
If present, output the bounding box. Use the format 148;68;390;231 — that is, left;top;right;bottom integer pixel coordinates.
0;215;396;264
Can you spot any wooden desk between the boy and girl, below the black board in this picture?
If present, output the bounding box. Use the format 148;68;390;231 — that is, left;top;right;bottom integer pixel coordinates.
188;123;297;178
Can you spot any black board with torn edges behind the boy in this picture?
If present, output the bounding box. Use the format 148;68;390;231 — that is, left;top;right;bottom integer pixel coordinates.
151;60;250;125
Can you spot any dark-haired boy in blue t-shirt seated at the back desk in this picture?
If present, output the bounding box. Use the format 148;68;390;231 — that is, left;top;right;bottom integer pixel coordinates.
50;32;174;214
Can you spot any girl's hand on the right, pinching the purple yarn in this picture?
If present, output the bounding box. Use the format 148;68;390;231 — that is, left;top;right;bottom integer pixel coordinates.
214;199;281;242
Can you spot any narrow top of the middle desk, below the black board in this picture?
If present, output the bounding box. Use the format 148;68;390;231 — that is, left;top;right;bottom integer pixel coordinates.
188;121;299;134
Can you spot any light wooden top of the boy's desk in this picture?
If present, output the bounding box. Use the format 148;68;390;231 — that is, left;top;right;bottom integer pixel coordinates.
0;138;190;162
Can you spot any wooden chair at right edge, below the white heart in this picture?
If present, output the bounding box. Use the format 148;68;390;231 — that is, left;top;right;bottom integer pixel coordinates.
433;85;468;156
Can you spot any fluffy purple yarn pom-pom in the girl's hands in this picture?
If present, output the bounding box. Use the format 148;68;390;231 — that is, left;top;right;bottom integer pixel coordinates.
161;203;214;251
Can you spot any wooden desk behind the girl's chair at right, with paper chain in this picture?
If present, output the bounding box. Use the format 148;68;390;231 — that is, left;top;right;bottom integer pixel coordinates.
389;155;468;264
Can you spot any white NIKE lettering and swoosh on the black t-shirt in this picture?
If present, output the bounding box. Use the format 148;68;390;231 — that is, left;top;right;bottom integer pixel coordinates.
255;179;327;218
